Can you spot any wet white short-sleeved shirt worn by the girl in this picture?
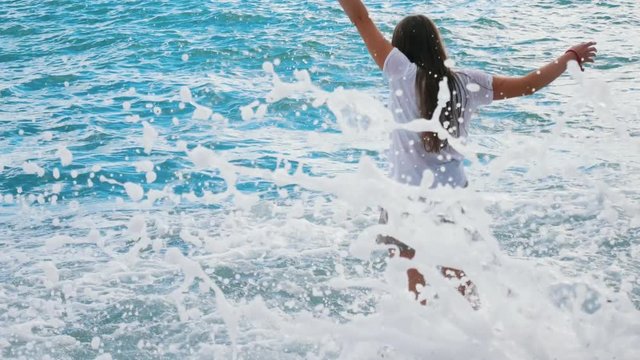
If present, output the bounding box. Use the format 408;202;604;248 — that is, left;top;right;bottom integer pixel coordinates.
383;48;493;187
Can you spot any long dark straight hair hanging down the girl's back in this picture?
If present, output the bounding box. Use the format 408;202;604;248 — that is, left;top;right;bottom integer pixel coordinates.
391;15;464;153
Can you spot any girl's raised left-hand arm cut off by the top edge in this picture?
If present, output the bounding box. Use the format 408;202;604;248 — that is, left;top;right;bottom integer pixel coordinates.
340;0;393;69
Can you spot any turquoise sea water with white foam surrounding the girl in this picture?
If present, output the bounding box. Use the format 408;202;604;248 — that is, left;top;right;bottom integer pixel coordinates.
0;0;640;359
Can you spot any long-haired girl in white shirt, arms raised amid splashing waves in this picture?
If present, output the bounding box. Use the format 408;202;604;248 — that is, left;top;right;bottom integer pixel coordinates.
340;0;597;304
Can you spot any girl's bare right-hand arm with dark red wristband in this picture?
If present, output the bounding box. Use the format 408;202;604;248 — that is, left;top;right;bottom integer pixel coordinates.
493;42;597;100
